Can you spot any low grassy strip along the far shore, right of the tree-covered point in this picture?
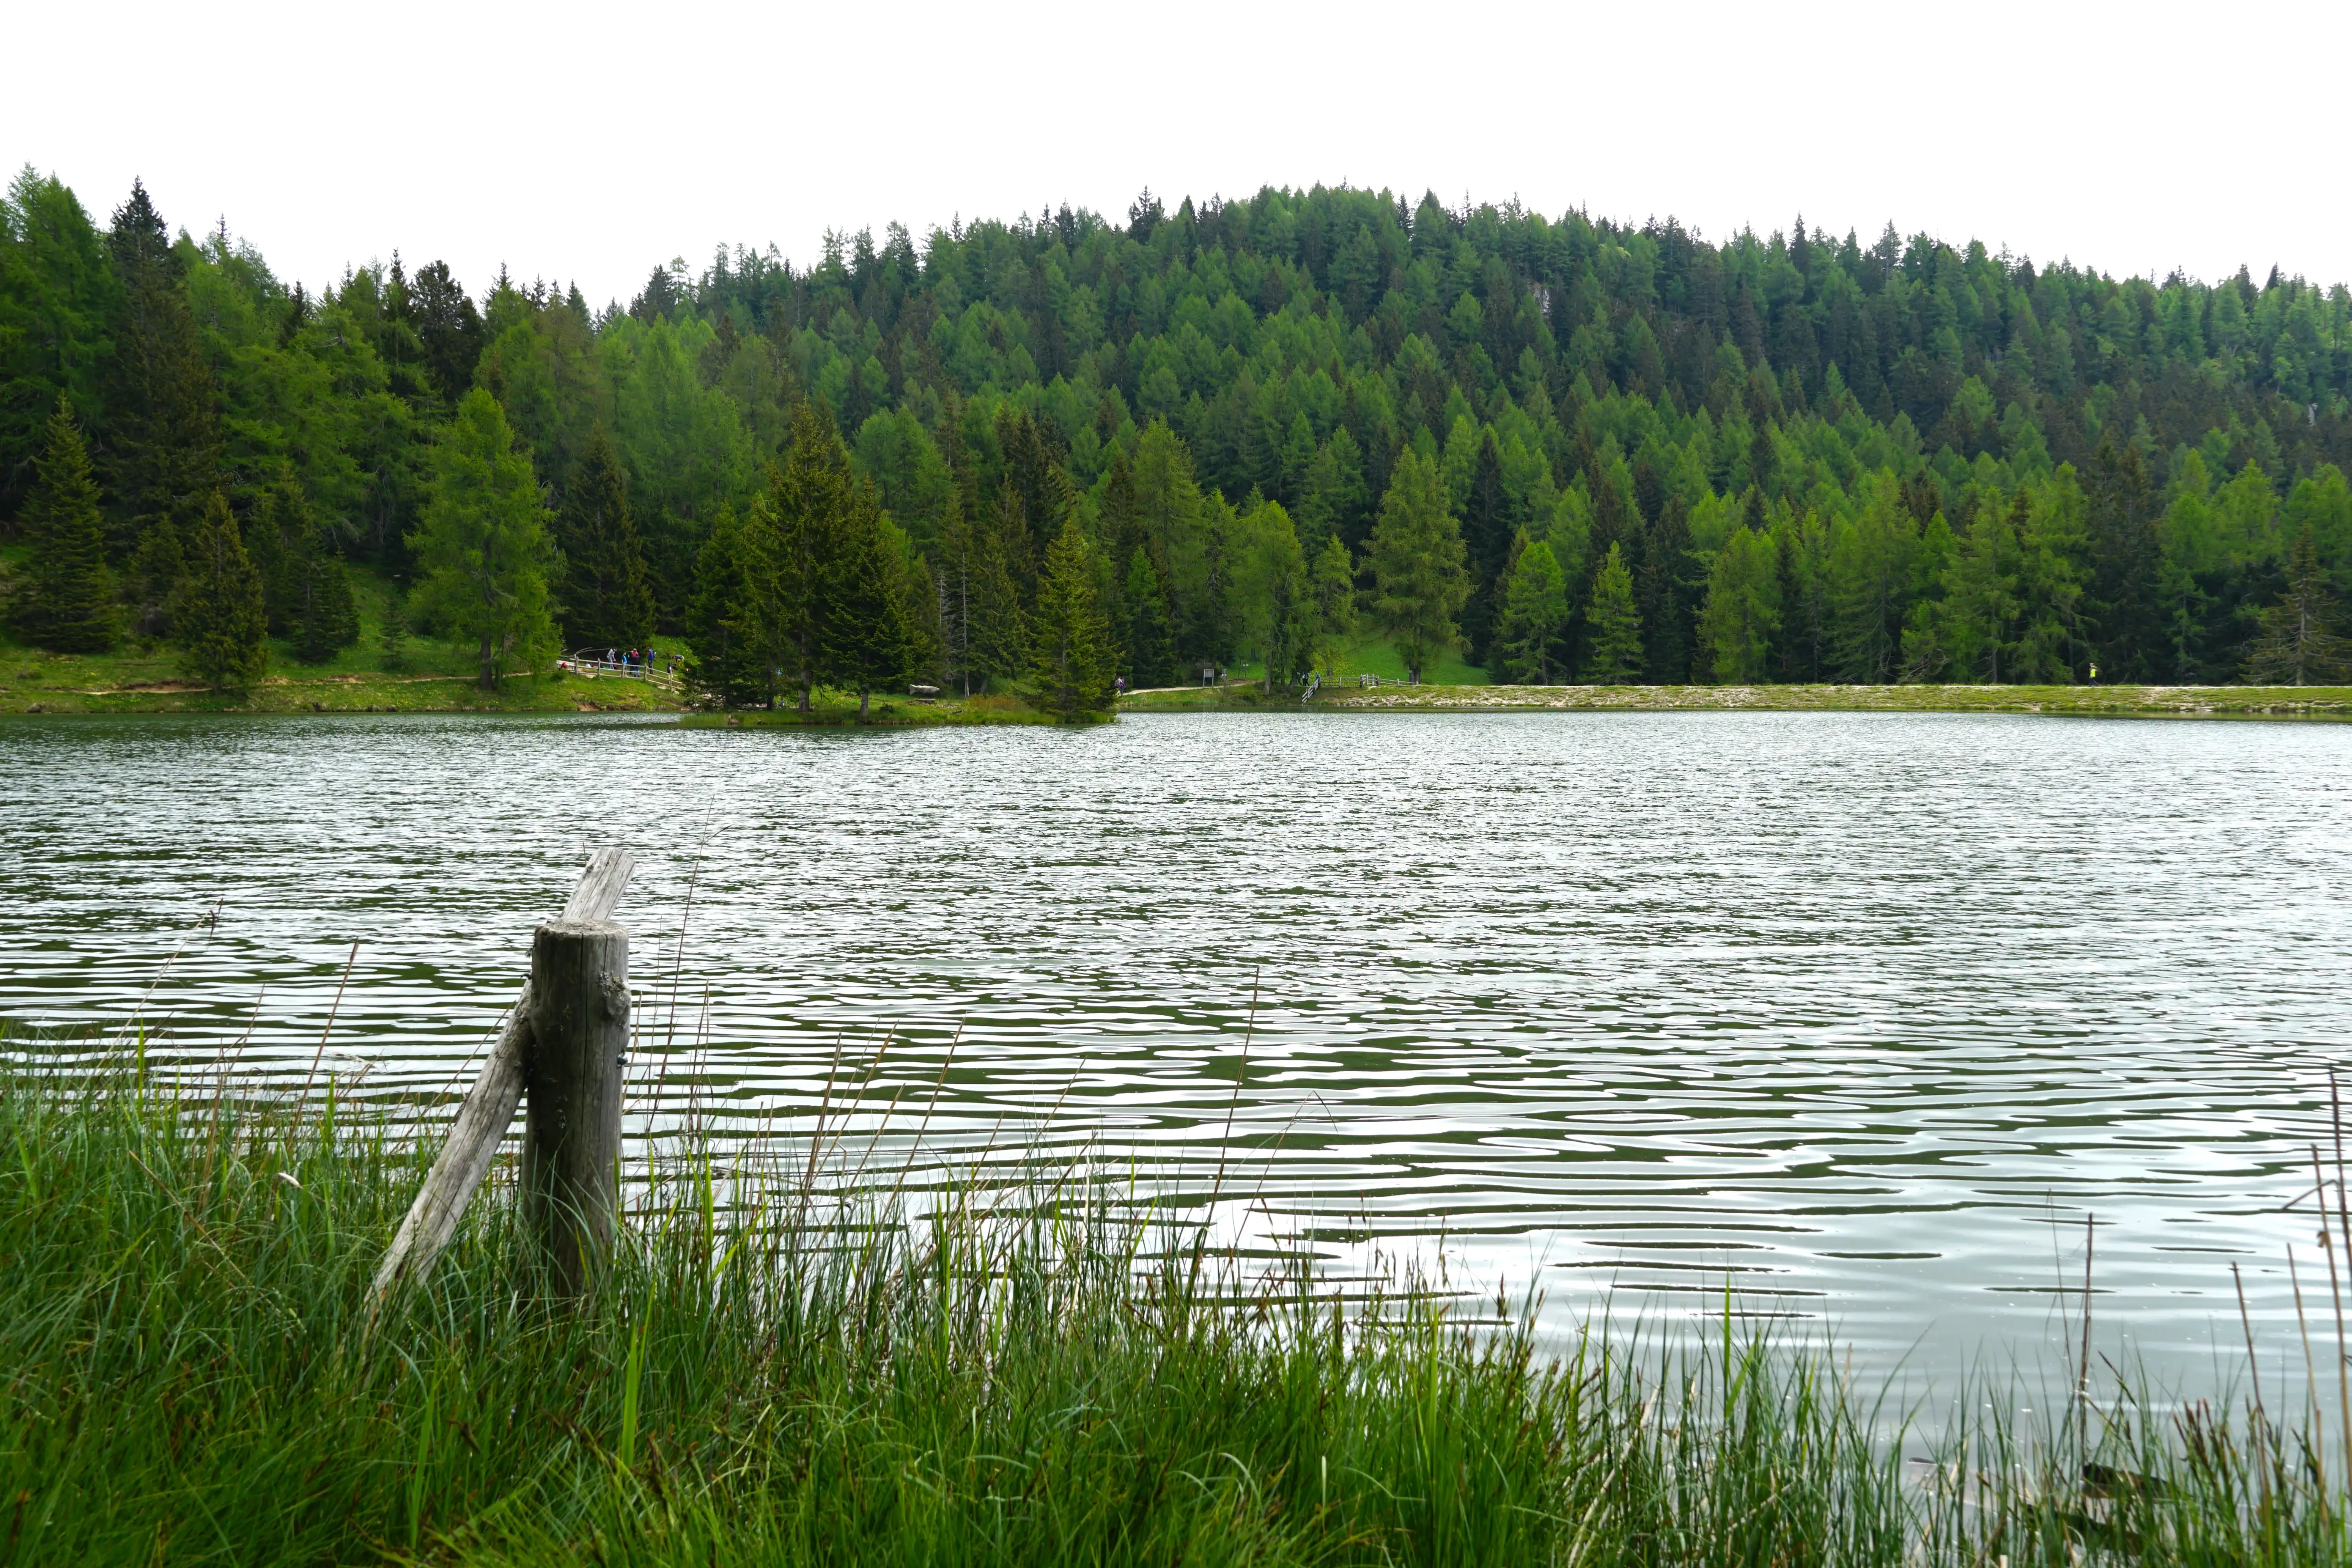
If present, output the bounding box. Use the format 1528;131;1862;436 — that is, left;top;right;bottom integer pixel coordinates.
1124;682;2352;719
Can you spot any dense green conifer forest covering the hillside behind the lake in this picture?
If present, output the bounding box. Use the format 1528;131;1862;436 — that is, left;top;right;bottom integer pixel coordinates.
0;171;2352;707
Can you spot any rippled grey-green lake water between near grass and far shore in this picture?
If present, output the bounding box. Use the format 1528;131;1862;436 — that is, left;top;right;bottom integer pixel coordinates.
0;715;2352;1380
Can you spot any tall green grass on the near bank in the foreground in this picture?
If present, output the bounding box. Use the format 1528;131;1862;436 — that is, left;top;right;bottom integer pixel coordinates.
0;1065;2345;1566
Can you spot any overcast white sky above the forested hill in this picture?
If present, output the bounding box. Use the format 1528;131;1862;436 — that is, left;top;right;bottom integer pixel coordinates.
0;0;2352;303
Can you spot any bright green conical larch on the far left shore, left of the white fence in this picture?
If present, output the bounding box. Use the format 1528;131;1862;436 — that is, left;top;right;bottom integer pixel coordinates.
409;388;555;691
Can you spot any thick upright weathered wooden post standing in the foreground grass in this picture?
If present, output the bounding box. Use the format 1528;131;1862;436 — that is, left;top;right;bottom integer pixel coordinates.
522;919;628;1295
